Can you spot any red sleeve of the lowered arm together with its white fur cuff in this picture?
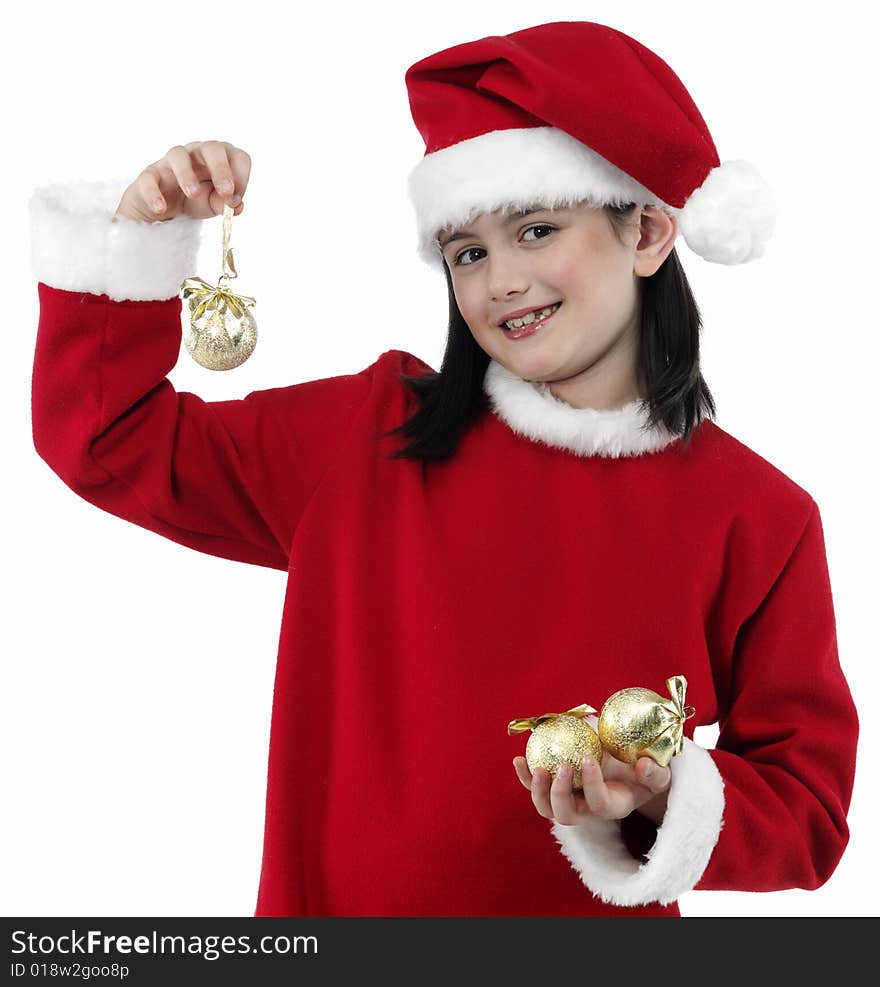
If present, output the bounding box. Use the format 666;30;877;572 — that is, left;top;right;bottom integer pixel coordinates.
552;500;858;905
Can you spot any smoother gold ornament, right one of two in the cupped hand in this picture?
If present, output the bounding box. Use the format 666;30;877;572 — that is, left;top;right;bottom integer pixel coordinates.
599;675;696;768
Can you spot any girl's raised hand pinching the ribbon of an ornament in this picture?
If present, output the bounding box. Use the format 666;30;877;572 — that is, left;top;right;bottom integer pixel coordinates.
116;141;251;223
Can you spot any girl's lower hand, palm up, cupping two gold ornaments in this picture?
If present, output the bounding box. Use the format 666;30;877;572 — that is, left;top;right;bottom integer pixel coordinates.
513;751;672;826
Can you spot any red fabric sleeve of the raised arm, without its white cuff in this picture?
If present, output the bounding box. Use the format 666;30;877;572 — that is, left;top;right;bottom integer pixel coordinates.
32;282;375;569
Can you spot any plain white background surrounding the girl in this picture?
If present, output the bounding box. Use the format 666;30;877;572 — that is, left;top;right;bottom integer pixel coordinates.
0;0;880;916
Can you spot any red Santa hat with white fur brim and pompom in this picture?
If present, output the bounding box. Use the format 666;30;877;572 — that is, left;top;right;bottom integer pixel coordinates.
406;21;775;270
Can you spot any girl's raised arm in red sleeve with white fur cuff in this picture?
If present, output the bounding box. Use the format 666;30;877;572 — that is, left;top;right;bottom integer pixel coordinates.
30;142;372;569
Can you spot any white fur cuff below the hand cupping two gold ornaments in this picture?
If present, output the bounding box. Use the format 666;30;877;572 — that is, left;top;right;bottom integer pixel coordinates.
551;738;724;905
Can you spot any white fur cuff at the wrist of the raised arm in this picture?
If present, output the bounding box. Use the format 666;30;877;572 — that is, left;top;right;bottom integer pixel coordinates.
28;179;202;301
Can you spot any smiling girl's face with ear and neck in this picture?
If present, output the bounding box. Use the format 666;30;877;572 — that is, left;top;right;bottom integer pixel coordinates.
439;204;677;408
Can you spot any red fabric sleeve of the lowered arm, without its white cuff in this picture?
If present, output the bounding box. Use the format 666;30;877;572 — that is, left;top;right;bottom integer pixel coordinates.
697;503;858;891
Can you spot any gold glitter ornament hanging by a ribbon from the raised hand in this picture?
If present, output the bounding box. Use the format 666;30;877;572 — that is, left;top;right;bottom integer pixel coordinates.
179;204;257;370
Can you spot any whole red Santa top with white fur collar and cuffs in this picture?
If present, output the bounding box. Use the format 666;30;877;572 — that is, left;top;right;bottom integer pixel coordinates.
32;179;858;916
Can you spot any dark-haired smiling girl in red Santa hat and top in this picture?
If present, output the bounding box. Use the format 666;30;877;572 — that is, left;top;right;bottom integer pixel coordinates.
31;22;858;916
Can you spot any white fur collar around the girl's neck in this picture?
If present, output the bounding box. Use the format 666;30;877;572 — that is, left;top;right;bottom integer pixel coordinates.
483;360;679;458
